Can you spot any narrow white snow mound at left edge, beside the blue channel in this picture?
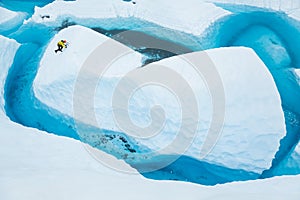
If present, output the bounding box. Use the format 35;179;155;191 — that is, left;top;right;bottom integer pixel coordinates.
0;35;20;112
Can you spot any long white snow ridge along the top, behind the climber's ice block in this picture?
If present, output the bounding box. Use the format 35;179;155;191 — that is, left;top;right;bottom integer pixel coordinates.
28;0;230;35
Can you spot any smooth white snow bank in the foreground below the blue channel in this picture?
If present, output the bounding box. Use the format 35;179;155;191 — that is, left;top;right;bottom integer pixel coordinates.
0;108;300;200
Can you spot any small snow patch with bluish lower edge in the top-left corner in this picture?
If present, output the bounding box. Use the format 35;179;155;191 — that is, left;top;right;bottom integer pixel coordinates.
0;7;26;33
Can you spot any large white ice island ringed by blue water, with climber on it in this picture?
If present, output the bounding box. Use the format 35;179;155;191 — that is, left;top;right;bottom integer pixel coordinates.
33;26;286;173
